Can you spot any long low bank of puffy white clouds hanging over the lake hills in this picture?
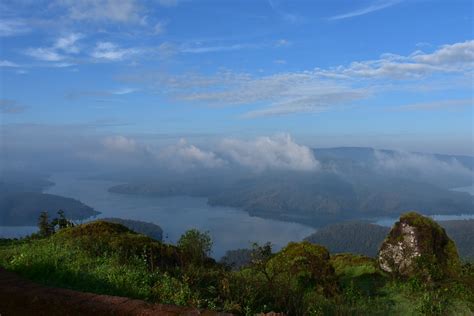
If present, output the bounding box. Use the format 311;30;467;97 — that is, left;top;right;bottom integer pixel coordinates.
94;134;320;171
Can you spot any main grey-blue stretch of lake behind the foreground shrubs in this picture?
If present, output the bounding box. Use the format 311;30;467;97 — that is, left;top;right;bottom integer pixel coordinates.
26;174;314;258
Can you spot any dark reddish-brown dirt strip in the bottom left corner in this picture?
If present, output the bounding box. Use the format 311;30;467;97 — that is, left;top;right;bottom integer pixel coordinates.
0;268;229;316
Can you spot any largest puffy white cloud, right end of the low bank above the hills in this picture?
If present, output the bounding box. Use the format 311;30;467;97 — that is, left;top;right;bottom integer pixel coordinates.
219;134;320;171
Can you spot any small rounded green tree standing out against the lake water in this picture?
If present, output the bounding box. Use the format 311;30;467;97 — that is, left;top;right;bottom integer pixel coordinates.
178;229;212;263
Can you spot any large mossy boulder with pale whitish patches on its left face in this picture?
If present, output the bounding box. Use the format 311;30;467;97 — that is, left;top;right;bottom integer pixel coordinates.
378;212;460;281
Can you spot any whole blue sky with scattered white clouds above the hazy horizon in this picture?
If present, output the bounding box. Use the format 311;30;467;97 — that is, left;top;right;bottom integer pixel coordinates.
0;0;474;157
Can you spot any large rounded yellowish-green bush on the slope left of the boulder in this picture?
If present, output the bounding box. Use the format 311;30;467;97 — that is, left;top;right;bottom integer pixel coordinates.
220;242;338;315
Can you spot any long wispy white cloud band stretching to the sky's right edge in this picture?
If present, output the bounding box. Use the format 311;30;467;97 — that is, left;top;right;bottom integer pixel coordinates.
118;40;474;118
